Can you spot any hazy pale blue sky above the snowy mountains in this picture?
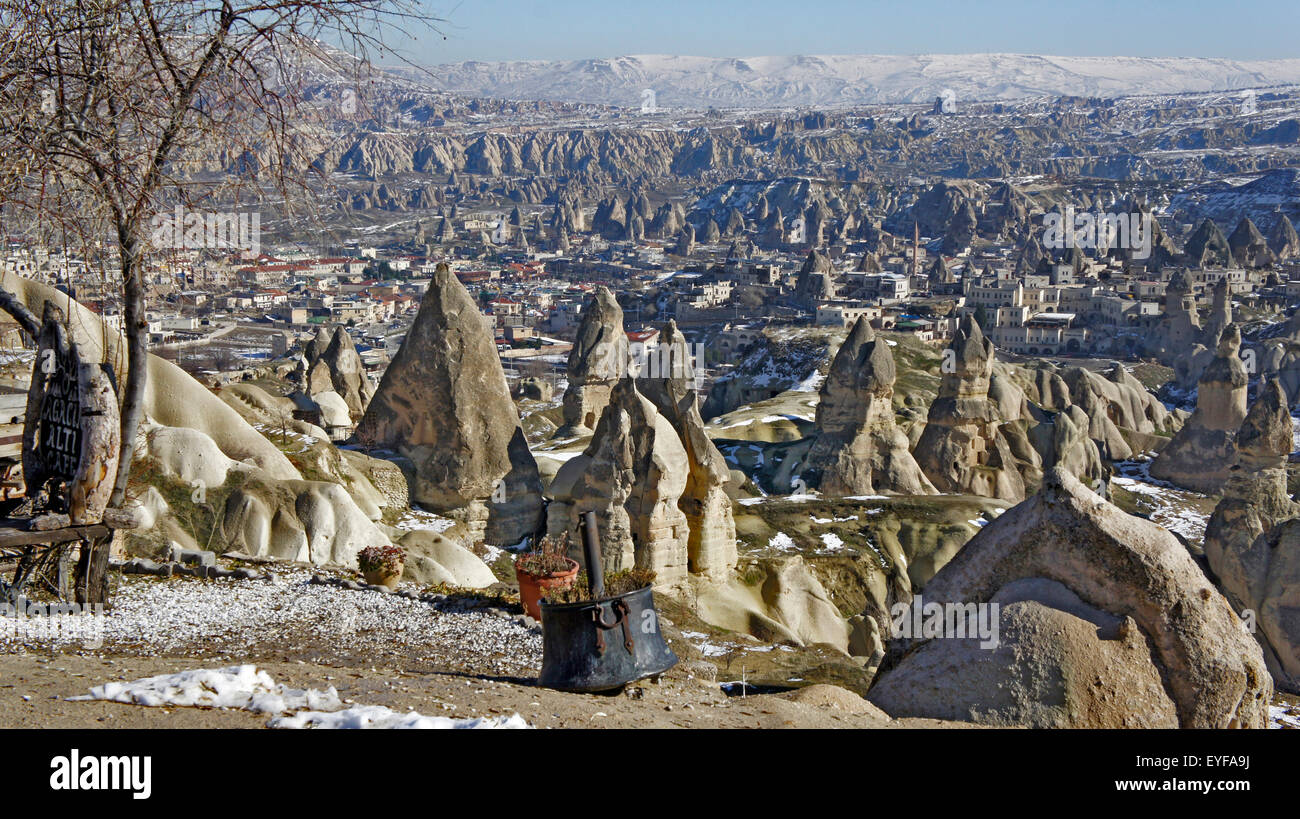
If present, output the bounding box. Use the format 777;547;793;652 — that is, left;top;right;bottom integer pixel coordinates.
390;0;1300;64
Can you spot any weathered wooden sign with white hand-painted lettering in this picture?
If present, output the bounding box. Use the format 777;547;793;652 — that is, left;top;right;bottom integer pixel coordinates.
22;303;121;524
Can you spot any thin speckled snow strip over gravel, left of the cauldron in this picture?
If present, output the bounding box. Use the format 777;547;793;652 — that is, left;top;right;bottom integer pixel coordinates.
0;569;542;673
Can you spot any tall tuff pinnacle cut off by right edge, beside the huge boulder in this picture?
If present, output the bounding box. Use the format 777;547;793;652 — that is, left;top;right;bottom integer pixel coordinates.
1205;378;1300;693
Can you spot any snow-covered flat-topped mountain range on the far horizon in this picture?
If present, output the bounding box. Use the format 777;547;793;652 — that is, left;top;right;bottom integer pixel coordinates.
410;55;1300;109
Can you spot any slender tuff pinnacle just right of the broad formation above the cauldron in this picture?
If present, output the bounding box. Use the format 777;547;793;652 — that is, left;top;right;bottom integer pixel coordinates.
637;320;738;580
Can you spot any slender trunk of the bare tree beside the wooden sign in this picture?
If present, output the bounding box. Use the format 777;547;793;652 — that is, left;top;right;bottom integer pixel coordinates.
105;231;150;509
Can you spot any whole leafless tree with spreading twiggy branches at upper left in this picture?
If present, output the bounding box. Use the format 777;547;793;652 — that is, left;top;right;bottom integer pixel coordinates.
0;0;433;506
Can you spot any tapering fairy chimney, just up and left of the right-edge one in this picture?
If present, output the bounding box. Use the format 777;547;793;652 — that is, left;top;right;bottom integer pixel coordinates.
1151;325;1248;494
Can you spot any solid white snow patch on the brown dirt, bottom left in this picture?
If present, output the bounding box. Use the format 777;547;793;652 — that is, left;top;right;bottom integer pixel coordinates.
68;664;528;728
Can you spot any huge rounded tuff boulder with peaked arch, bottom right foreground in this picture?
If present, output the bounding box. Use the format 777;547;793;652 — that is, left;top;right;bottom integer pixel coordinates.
868;468;1273;728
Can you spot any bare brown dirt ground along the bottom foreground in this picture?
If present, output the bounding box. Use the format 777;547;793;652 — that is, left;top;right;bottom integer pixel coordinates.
0;653;967;728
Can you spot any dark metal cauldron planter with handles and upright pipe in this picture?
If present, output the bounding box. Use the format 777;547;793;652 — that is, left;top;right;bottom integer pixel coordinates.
538;512;677;692
